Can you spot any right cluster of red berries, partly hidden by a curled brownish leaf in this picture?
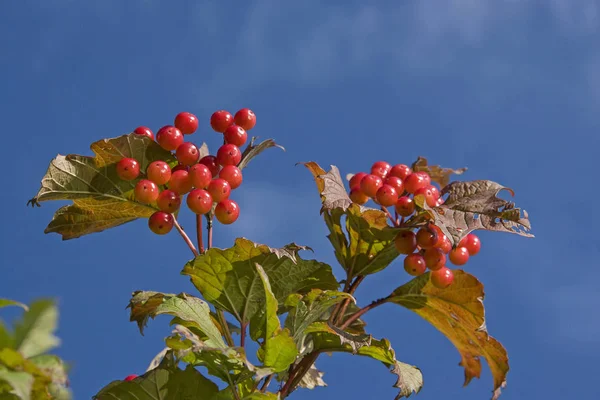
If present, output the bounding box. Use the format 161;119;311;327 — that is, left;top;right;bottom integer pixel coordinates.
350;161;481;289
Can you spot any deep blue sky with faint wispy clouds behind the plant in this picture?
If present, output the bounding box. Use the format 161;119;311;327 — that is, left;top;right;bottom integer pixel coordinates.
0;0;600;400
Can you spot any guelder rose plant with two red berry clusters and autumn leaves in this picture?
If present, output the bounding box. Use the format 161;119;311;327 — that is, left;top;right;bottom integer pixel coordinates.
25;108;532;400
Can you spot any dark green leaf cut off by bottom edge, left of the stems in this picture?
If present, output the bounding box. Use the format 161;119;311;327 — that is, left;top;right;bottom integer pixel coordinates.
94;356;219;400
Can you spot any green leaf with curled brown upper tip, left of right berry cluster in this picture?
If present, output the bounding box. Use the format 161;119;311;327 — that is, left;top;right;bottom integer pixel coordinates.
304;162;398;279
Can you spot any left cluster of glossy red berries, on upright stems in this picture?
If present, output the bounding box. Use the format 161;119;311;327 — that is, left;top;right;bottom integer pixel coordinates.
123;108;256;235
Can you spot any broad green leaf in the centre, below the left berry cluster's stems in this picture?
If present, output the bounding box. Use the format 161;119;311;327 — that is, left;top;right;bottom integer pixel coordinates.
182;238;339;324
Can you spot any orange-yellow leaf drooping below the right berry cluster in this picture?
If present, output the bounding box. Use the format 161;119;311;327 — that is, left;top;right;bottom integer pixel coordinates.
389;270;509;399
